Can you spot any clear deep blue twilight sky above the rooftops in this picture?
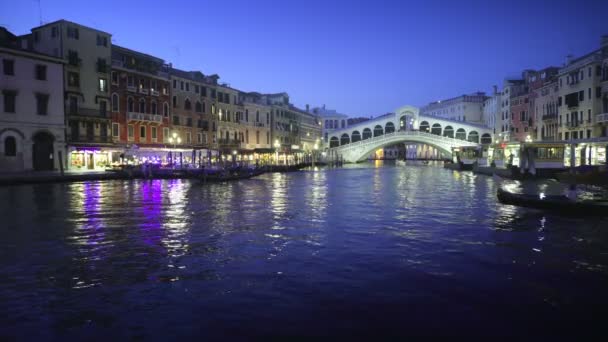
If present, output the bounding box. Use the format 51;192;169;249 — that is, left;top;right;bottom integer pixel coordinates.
0;0;608;116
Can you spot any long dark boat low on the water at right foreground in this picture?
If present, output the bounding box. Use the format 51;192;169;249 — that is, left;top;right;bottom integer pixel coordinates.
497;188;608;216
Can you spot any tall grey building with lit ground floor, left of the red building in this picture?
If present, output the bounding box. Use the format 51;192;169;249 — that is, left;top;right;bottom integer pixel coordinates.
27;20;118;169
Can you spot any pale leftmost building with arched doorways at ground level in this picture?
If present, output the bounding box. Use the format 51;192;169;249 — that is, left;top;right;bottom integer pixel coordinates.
0;27;66;172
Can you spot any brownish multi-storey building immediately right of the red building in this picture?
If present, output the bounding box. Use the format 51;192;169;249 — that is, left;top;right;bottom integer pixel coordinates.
169;68;219;162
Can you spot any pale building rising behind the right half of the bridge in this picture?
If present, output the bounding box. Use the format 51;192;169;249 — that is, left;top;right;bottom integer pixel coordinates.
420;92;487;124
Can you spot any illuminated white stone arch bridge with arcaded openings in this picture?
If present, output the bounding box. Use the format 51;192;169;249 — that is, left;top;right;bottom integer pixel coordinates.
327;106;492;163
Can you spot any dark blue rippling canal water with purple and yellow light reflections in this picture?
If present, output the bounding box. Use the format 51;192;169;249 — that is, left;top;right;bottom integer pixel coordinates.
0;164;608;340
